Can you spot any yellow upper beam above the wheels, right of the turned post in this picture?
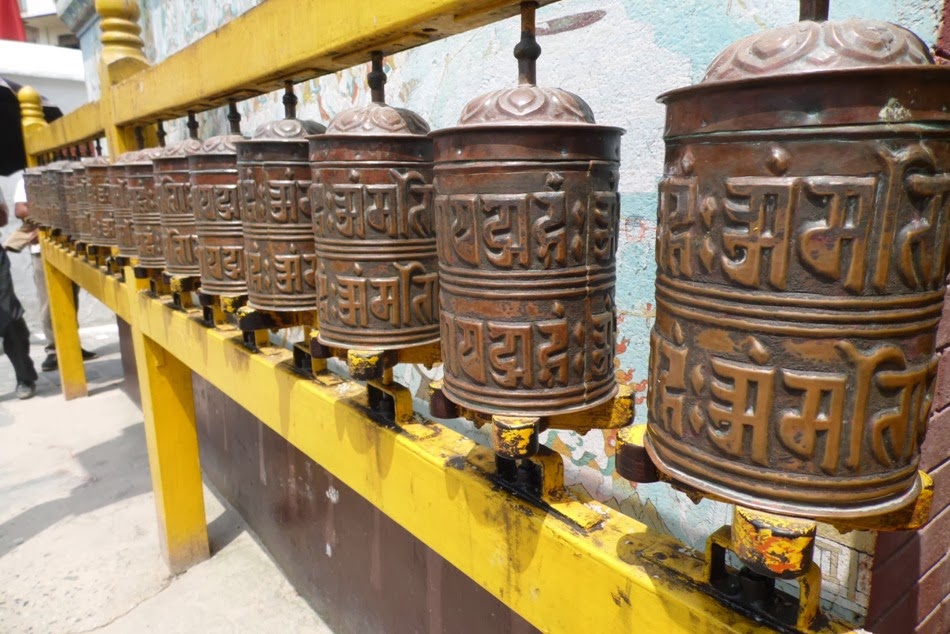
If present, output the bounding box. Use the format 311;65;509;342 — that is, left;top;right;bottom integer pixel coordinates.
110;0;552;126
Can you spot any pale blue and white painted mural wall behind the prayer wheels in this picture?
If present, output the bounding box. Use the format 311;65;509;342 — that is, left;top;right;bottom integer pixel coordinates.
67;0;942;624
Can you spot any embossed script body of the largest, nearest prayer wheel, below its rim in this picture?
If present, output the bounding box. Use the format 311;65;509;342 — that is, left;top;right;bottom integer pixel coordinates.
648;134;950;513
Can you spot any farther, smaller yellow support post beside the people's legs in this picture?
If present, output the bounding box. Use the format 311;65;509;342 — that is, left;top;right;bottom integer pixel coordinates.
41;240;89;401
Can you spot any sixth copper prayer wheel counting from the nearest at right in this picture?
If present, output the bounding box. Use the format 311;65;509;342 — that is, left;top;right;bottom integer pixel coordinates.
152;139;201;277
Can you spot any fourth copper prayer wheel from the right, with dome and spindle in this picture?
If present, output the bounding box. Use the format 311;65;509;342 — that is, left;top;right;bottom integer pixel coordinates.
237;82;325;312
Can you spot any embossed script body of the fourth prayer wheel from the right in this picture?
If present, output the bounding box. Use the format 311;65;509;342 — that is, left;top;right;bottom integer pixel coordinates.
238;162;317;311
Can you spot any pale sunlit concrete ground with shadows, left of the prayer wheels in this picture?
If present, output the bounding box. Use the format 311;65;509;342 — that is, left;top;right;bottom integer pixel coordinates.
0;326;332;634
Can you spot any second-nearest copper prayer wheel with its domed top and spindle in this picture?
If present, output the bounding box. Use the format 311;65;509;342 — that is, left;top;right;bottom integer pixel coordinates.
431;3;623;416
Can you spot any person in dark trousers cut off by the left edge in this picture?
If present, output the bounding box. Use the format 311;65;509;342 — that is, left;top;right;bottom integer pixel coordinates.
0;185;38;399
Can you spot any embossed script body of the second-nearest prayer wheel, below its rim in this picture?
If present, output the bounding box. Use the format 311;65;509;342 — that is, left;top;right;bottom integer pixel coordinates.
435;161;619;415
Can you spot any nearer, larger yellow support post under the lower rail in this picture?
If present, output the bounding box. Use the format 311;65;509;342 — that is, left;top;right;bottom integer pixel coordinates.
132;324;210;574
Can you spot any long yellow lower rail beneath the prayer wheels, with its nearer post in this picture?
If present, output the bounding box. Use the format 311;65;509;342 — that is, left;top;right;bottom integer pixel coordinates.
43;240;843;633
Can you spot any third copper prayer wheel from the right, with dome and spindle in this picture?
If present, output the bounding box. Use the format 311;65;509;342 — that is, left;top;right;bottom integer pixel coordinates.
310;53;439;350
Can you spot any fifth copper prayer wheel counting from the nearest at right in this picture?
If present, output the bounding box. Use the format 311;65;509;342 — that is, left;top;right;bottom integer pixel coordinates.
188;101;247;295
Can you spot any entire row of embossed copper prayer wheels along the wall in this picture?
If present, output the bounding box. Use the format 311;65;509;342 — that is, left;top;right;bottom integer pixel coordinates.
27;3;950;544
